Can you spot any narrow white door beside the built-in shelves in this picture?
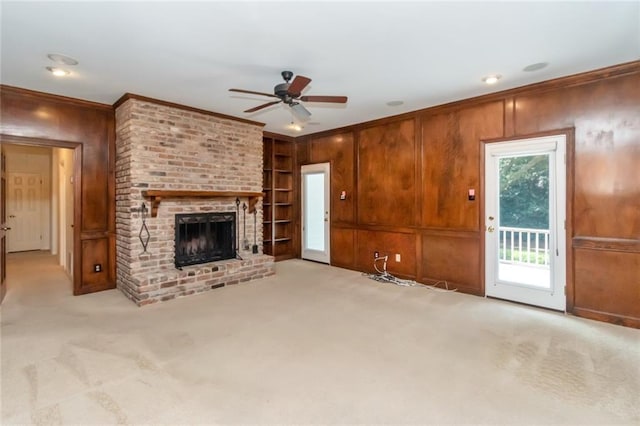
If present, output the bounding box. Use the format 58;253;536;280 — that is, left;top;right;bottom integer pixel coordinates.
301;163;331;263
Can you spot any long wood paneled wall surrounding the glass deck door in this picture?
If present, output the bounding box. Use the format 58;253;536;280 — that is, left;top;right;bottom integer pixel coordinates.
298;62;640;327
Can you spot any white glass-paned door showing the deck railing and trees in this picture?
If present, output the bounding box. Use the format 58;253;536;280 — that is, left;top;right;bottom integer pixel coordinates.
485;135;566;311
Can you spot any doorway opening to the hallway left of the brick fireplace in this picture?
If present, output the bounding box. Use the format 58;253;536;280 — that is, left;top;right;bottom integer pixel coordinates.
2;141;76;294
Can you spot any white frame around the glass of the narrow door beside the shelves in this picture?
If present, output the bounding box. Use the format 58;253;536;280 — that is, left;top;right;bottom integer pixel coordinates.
300;163;331;264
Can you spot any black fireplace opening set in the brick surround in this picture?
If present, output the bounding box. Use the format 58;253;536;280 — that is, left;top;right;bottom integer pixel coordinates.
175;212;236;268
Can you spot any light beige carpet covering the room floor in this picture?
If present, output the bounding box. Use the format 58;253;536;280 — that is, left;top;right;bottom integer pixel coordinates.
1;254;640;425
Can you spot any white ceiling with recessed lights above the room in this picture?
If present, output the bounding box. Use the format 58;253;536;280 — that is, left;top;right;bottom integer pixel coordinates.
0;0;640;135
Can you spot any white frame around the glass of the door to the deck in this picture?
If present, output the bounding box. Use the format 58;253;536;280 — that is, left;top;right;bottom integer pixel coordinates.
484;135;567;311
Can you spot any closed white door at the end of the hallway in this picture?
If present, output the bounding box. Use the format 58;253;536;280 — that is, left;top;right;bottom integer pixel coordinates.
7;173;46;252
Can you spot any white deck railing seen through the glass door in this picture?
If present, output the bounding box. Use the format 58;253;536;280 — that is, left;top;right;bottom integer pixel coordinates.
498;226;549;265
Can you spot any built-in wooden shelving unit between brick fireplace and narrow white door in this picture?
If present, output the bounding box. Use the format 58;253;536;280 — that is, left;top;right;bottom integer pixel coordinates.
262;135;295;261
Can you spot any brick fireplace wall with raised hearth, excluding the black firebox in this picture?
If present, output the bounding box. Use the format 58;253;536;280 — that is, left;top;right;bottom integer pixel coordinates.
116;96;274;306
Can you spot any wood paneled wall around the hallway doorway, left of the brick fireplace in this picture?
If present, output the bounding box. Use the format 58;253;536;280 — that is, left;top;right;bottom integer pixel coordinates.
0;86;115;294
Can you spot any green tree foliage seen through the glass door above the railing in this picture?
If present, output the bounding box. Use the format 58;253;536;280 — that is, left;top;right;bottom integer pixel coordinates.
499;155;549;229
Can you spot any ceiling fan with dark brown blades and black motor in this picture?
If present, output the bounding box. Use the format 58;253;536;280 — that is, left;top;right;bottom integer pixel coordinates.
229;71;347;118
